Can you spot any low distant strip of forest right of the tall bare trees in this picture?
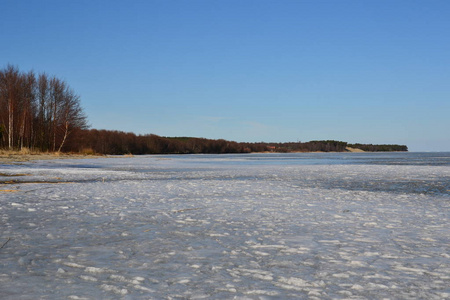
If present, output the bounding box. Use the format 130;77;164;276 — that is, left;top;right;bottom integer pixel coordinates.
64;129;407;155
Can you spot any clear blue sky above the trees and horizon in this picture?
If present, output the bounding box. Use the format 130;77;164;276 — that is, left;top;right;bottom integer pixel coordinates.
0;0;450;151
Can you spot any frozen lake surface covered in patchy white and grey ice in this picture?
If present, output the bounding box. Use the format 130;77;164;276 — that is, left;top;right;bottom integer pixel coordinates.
0;153;450;299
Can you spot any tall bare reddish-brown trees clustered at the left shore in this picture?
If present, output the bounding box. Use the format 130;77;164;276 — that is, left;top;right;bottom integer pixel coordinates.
0;65;88;151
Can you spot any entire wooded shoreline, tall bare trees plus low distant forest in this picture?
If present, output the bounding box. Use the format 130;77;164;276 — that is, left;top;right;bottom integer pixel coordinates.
0;65;408;154
